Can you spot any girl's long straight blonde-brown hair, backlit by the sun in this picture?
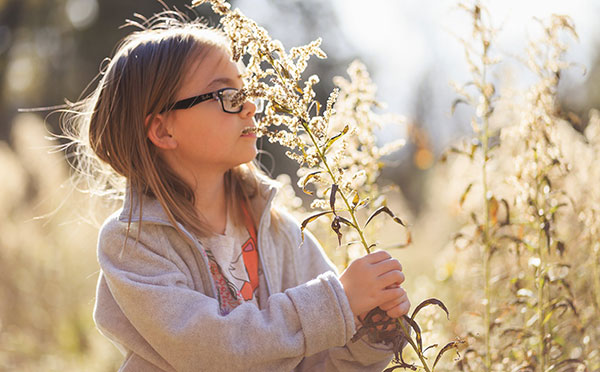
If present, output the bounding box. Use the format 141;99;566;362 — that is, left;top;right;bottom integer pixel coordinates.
61;10;278;241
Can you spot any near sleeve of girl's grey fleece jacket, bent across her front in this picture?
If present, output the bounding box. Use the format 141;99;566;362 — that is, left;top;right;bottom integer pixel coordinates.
95;220;354;371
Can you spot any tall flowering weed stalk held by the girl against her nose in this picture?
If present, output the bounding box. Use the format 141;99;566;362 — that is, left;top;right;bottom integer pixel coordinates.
192;0;458;372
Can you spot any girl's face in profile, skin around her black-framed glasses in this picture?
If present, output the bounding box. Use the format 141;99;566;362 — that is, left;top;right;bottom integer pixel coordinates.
164;48;257;181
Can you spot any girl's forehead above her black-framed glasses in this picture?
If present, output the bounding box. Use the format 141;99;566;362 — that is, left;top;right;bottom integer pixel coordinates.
179;46;242;96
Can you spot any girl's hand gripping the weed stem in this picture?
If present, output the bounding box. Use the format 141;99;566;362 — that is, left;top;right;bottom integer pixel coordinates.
340;251;410;322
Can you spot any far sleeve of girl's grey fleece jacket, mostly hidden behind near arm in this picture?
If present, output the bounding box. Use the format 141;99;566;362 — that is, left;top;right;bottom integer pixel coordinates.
278;214;393;372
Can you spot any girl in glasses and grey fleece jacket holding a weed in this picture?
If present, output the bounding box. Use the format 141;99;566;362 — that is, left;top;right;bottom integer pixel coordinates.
71;8;410;371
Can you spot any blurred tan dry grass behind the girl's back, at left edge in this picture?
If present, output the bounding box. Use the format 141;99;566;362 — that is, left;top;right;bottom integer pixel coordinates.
0;115;119;371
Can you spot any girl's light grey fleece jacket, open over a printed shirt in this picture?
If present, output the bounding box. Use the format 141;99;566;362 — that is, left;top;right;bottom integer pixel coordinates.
94;176;392;372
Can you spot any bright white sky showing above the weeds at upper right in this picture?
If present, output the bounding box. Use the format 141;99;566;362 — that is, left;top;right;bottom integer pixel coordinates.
231;0;600;149
